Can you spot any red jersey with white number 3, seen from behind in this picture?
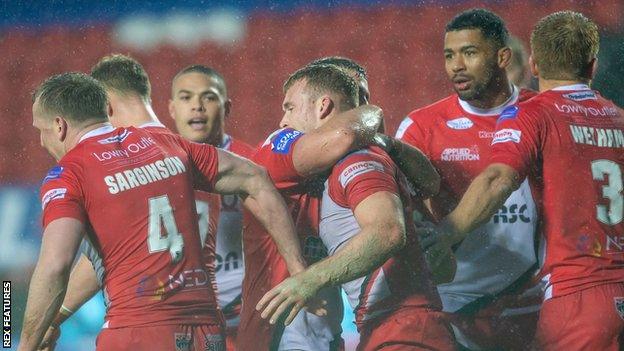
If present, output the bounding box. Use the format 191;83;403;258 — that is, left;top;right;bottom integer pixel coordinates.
490;84;624;298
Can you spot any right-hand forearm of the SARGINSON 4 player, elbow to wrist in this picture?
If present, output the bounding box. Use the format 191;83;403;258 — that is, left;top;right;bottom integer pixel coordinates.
244;173;306;274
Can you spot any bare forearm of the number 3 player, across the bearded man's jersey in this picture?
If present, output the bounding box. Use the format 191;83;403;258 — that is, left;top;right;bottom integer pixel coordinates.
440;165;519;245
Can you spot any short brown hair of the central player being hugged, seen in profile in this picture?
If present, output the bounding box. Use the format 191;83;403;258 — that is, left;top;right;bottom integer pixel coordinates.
284;64;359;110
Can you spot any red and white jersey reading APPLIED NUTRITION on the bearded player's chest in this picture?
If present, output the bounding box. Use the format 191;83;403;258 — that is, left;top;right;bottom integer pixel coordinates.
396;87;540;312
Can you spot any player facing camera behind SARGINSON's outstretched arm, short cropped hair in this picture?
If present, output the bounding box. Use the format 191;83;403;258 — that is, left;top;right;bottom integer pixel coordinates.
169;65;253;350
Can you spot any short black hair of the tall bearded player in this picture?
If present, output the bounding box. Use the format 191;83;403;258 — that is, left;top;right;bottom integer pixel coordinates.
446;9;509;50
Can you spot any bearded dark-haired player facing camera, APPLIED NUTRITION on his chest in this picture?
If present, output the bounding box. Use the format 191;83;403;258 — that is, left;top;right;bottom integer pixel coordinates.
396;9;540;349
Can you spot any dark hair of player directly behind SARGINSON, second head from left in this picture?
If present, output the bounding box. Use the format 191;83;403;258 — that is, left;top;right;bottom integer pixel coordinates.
91;54;152;102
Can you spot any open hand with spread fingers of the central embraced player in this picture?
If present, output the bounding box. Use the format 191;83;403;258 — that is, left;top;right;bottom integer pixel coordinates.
256;272;327;325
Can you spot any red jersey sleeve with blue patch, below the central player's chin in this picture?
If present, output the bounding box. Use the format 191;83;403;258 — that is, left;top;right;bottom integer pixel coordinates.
252;128;303;190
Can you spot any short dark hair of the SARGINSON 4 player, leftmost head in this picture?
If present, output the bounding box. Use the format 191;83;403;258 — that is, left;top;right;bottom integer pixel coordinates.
33;72;108;124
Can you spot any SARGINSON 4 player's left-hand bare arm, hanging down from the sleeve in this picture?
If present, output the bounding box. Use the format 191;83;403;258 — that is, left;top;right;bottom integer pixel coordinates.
18;218;84;351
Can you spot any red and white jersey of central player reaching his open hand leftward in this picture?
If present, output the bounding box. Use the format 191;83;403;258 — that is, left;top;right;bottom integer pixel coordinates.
320;147;440;328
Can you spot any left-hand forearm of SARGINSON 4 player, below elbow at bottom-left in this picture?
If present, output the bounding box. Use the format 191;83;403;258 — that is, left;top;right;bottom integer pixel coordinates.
19;261;69;351
